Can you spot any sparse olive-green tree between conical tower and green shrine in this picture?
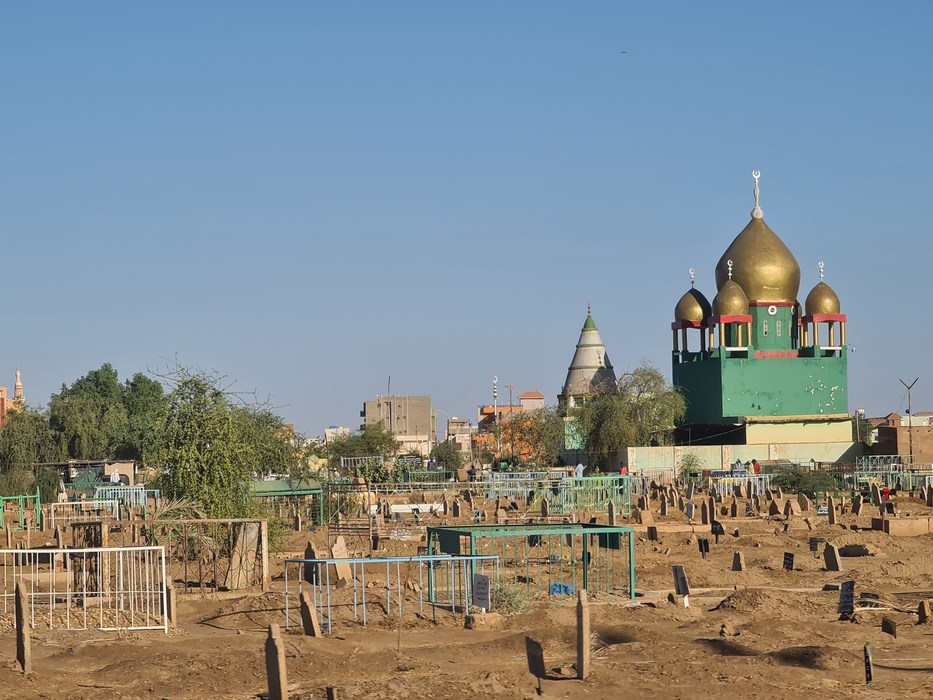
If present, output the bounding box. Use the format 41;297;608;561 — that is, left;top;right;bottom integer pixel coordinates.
572;364;686;465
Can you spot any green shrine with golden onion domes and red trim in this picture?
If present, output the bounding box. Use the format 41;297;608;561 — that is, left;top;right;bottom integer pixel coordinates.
671;171;851;444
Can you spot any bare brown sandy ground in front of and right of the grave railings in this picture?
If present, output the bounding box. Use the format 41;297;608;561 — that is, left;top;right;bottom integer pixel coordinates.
0;492;933;700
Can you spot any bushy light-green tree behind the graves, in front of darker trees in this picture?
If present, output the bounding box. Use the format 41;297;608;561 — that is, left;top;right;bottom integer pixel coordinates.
152;369;296;518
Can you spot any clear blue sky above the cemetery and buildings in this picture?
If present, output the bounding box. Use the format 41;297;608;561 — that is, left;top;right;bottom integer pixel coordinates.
0;0;933;435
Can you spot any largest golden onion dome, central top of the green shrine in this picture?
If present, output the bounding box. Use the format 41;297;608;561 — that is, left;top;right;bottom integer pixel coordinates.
716;218;800;304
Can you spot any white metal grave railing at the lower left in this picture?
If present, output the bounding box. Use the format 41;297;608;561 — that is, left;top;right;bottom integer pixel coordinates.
0;547;168;632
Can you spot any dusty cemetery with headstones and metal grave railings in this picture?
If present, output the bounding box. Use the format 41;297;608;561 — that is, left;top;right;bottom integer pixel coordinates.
0;474;933;699
